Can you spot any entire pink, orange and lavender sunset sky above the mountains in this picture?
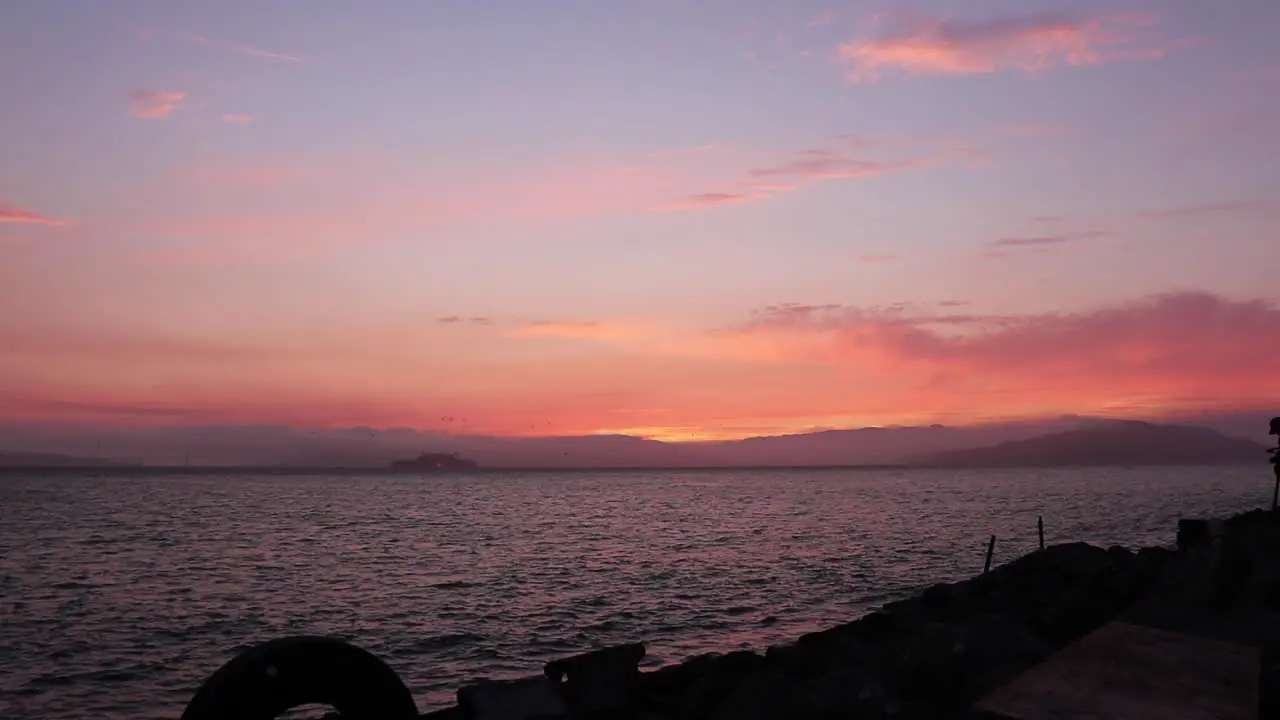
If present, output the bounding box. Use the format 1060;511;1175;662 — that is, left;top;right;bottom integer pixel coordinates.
0;0;1280;439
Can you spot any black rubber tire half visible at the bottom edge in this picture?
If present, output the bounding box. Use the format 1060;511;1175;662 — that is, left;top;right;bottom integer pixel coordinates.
182;635;419;720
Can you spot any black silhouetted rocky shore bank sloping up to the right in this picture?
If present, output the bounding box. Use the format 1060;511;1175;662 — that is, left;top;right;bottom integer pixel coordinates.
184;510;1280;720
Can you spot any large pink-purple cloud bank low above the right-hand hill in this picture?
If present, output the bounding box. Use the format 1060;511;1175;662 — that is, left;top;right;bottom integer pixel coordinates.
721;291;1280;409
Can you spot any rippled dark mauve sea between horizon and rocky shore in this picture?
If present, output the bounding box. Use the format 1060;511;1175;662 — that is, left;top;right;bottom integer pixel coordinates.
0;462;1271;720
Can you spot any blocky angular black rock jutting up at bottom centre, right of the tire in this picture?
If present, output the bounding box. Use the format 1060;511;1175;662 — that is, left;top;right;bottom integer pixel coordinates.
545;643;645;714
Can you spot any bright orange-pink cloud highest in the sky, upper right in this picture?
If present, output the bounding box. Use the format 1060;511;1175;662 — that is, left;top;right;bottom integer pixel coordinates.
837;14;1160;82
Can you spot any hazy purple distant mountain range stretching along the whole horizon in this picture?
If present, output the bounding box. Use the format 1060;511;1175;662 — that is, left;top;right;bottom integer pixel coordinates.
0;414;1270;469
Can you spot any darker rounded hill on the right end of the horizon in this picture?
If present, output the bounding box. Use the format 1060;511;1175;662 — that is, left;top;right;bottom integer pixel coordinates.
906;420;1266;468
